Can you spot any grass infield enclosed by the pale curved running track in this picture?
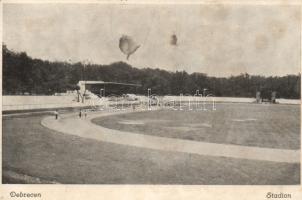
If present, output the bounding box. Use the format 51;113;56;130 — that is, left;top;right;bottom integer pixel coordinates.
93;104;300;149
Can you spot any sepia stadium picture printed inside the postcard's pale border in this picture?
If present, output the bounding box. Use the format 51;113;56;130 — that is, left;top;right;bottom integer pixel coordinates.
2;1;301;189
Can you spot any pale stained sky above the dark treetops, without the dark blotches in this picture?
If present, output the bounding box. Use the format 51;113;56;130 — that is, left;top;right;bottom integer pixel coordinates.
3;4;301;77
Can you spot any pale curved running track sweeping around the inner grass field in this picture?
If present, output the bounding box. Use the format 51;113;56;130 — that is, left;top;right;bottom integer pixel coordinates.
41;111;300;163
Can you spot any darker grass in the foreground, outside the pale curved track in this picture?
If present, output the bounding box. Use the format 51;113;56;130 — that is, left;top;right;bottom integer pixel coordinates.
2;109;300;184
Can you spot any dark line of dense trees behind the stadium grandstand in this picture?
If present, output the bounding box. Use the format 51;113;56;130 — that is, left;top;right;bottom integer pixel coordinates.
2;45;301;99
